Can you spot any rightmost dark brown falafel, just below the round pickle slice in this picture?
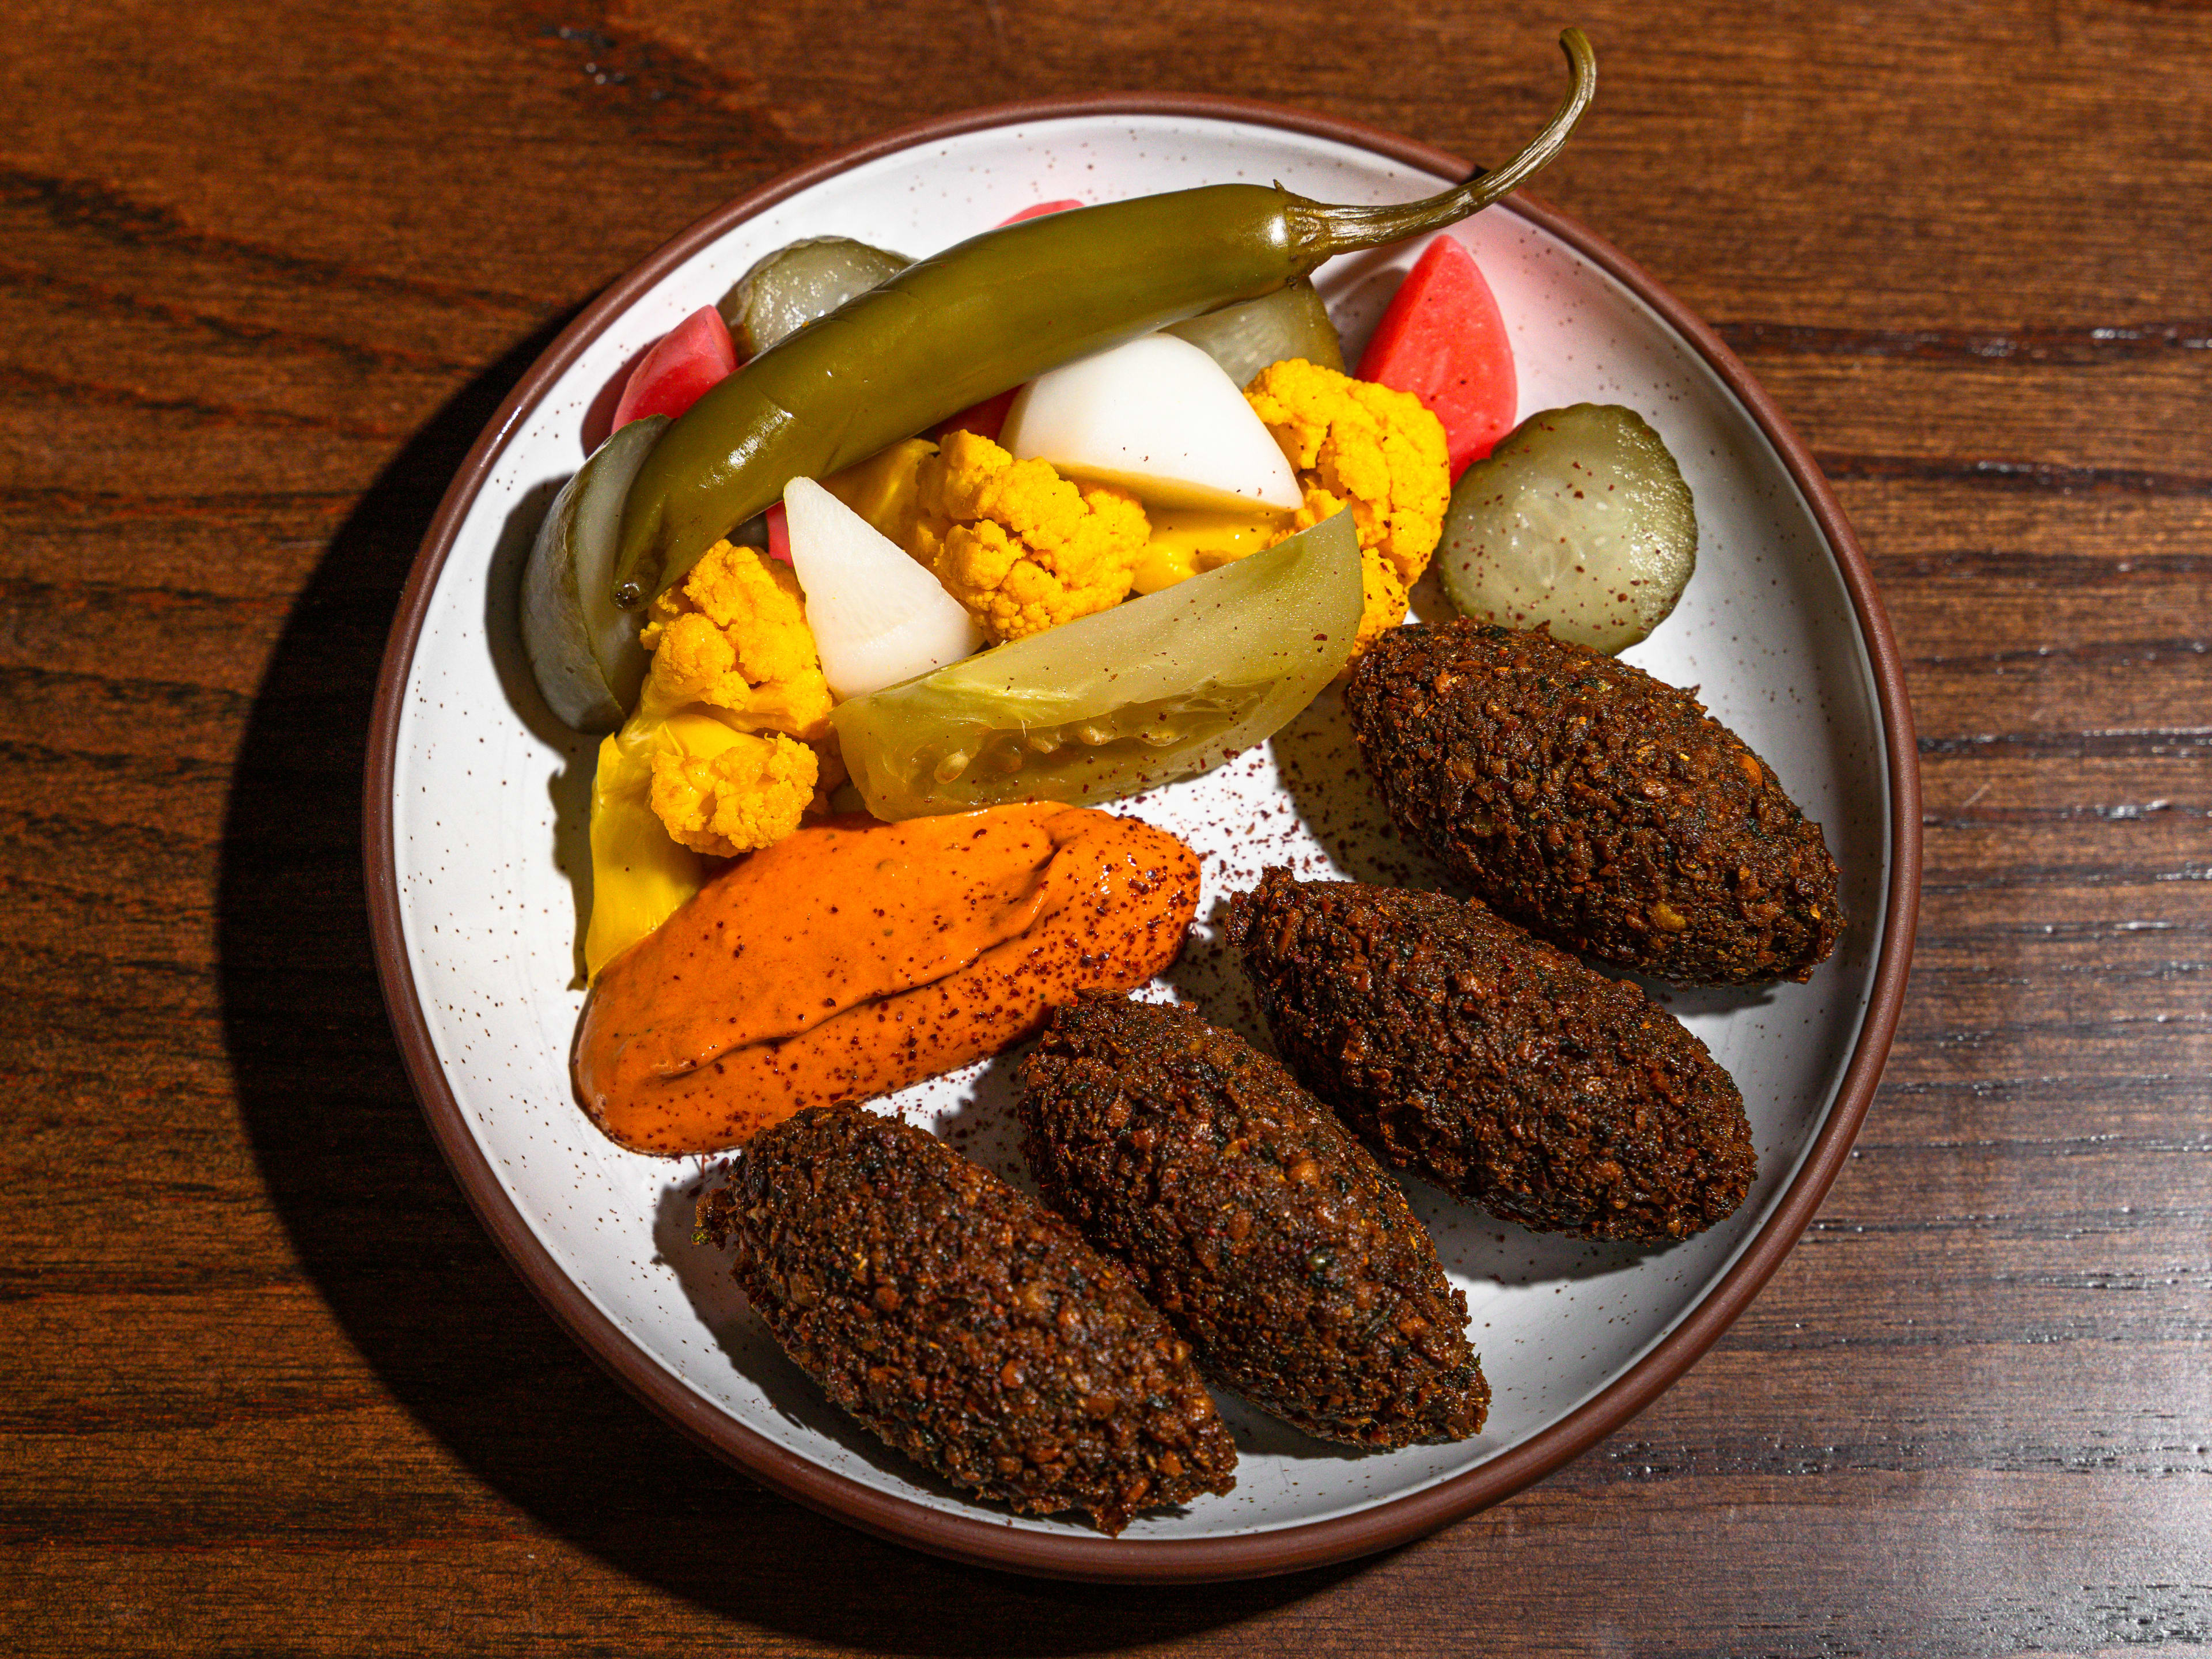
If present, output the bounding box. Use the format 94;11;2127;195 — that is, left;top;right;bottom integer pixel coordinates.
1345;619;1843;984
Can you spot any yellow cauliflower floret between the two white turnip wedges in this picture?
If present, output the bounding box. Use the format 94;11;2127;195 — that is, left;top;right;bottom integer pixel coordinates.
905;431;1150;642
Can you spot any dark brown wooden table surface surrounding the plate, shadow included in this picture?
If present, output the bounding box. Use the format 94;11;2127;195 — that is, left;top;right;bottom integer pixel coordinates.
0;0;2212;1654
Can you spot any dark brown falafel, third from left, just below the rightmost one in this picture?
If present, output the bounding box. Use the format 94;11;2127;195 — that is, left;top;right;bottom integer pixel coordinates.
1230;869;1756;1243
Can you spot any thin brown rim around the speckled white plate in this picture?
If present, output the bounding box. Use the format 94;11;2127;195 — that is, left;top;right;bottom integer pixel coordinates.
363;93;1920;1584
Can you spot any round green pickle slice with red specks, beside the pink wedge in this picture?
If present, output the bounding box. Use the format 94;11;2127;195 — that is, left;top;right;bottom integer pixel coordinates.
1435;403;1696;655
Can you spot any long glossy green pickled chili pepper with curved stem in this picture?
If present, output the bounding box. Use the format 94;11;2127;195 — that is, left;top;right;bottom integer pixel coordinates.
615;29;1597;608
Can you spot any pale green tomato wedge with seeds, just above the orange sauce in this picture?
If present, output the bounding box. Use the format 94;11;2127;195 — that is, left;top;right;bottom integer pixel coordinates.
830;513;1361;819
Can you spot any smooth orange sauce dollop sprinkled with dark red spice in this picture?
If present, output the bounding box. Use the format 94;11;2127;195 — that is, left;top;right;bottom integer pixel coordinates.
575;805;1199;1153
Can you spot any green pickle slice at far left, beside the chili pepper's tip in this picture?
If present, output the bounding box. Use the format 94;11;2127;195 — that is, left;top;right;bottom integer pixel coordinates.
522;416;668;732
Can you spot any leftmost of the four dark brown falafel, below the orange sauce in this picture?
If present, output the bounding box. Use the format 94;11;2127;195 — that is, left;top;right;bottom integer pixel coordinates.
699;1106;1237;1533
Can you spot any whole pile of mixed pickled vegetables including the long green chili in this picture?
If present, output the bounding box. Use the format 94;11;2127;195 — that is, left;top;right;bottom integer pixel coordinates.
502;31;1694;1052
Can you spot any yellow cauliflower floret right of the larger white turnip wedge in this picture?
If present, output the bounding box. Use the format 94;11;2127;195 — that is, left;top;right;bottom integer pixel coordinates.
1245;356;1451;650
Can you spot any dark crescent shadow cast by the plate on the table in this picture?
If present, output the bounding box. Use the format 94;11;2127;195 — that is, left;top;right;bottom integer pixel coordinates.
217;319;1358;1654
